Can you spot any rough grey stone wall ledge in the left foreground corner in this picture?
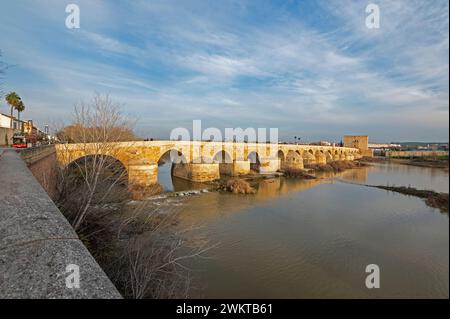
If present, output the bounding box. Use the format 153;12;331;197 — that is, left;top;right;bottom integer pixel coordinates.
0;150;121;299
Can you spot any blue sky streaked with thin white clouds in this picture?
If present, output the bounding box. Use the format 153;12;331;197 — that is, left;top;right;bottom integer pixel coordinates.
0;0;449;142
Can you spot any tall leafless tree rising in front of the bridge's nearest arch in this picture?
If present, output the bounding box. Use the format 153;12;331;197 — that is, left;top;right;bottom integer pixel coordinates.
57;94;134;230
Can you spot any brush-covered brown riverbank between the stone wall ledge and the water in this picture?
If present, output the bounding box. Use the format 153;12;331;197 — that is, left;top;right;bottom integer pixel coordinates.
67;198;209;299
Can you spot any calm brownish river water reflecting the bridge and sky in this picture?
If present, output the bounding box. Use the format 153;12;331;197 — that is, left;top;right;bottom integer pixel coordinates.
156;164;449;298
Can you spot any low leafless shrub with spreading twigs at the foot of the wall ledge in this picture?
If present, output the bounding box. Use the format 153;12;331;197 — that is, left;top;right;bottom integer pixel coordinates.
107;202;213;299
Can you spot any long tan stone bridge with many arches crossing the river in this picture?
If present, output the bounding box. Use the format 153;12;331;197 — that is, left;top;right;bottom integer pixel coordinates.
56;141;361;187
